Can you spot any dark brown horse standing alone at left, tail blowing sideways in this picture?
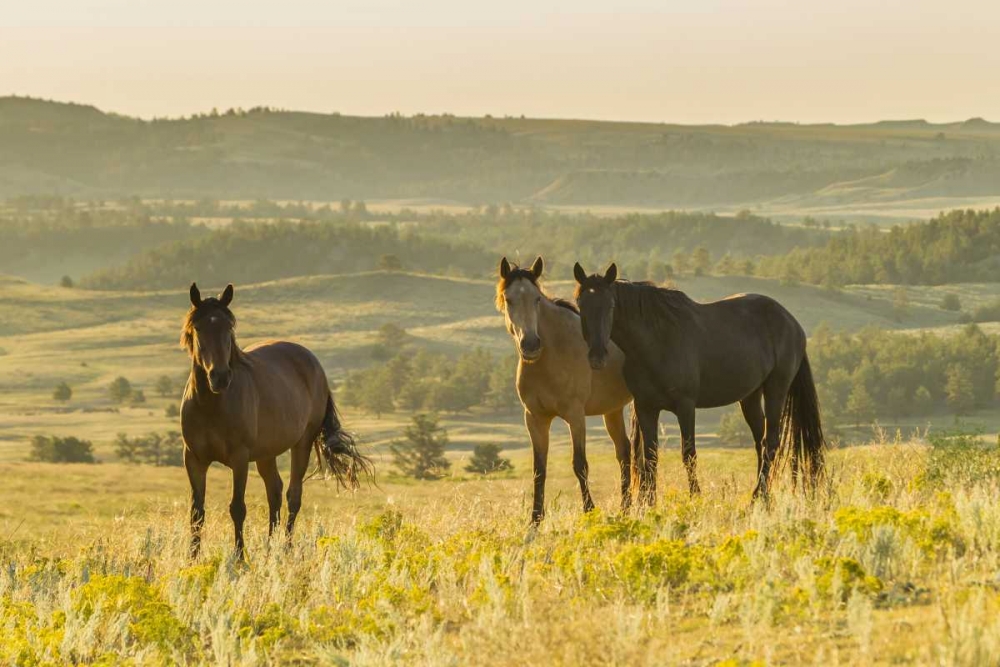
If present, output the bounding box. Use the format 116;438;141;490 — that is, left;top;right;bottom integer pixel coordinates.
181;283;373;559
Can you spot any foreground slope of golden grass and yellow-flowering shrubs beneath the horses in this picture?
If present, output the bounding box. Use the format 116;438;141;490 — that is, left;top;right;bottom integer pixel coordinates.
0;444;1000;665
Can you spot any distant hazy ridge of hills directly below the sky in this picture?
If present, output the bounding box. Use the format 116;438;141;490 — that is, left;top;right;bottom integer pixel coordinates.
0;98;1000;207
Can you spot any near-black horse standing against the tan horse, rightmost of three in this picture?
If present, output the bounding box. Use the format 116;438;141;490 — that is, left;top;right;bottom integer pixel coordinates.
573;263;826;503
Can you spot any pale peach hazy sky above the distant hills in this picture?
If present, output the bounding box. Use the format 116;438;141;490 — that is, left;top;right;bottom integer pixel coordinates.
0;0;1000;123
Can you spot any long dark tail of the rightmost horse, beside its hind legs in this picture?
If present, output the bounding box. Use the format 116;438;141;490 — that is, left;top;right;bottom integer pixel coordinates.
779;356;826;486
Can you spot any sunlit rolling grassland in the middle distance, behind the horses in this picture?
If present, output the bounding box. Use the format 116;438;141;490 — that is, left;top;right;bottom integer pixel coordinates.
0;272;958;460
